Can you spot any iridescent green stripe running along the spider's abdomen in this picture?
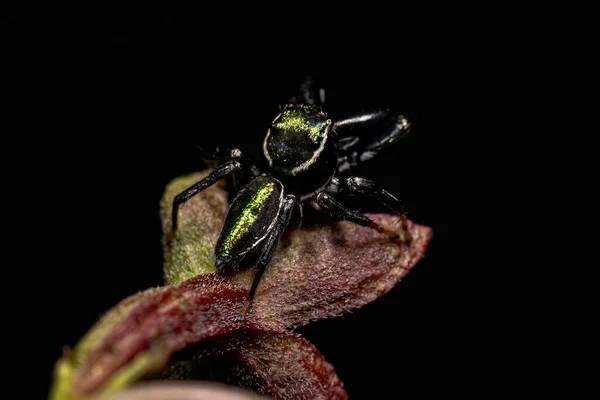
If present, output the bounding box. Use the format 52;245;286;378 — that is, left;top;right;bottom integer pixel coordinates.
221;182;276;258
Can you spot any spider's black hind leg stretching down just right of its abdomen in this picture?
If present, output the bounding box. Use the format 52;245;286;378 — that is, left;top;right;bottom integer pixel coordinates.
238;194;297;319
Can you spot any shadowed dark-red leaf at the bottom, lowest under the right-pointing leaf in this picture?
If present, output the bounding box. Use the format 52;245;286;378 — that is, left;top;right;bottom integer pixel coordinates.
163;327;347;400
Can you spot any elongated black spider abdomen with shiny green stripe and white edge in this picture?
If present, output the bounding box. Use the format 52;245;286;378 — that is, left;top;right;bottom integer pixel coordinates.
215;176;283;270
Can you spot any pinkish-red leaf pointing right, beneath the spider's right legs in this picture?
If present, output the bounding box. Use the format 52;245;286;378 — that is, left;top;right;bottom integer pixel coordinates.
254;214;431;327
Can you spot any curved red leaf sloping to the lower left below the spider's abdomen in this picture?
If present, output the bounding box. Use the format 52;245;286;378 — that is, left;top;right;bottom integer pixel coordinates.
74;274;253;394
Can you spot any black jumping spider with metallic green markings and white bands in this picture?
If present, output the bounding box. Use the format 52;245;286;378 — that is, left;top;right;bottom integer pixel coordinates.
167;78;411;318
